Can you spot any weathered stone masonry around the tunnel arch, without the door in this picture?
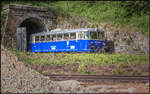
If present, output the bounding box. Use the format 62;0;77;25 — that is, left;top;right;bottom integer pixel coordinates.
3;4;57;48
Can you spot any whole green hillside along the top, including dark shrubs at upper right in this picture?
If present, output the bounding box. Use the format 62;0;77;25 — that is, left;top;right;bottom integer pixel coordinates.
2;1;149;34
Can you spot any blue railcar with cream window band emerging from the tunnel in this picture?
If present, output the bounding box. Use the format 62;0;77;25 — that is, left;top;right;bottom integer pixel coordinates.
30;28;105;52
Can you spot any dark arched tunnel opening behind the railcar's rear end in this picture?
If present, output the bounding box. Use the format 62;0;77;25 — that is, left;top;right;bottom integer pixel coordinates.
19;18;46;51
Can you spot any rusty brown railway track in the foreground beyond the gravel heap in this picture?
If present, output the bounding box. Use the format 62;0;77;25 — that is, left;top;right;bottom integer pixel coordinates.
46;74;149;82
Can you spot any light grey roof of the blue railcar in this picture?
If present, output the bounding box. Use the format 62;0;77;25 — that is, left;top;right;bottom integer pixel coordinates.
32;28;104;36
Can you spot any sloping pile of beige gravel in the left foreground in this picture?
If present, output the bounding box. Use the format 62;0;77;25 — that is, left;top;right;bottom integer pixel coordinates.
1;46;94;93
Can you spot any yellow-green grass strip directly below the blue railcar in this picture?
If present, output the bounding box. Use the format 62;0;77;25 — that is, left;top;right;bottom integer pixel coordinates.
8;48;149;67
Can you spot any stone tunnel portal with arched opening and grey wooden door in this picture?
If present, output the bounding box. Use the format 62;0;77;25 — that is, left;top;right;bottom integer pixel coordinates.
2;4;58;51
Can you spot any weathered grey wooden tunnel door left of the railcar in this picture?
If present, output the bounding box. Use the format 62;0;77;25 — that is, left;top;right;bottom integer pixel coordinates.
16;27;27;51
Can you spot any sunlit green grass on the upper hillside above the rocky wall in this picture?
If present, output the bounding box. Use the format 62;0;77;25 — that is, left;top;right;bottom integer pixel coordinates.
49;1;149;34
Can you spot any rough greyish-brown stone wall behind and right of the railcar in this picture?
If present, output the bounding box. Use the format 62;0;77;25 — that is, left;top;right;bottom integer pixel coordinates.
57;16;149;54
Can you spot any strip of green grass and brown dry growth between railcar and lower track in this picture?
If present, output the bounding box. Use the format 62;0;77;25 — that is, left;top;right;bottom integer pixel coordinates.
8;48;149;75
